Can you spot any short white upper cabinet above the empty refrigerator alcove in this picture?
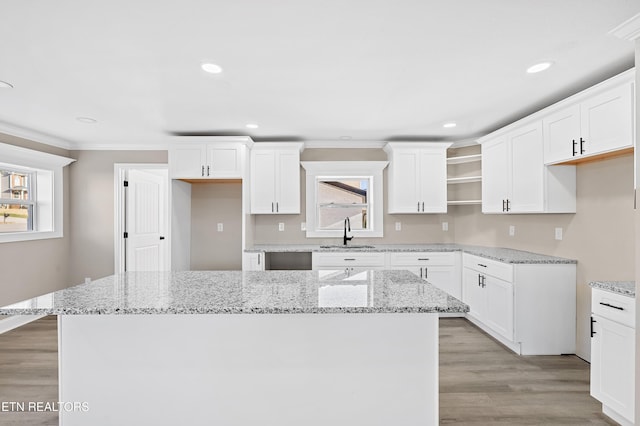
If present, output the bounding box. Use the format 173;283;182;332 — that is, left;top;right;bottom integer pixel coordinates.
169;137;245;179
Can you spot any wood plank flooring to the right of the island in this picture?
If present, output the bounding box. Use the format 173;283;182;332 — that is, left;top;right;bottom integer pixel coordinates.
440;318;617;425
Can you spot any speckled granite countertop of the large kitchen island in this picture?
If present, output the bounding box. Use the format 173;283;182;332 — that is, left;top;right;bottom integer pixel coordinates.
0;270;469;315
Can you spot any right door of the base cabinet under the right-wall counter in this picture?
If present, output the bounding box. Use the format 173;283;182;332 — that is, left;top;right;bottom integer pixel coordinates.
483;276;513;340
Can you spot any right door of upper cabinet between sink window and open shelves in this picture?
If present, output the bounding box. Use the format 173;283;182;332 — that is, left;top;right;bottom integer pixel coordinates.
419;150;447;213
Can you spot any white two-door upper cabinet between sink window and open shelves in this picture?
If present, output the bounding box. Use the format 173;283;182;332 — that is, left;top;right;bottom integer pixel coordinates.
384;142;451;214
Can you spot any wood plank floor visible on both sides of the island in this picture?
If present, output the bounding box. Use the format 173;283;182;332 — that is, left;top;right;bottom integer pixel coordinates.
0;317;616;426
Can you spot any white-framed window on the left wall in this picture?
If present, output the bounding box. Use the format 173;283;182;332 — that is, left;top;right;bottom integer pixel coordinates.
0;143;73;243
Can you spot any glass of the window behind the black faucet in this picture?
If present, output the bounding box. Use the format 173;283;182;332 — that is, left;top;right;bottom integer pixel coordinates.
317;177;370;230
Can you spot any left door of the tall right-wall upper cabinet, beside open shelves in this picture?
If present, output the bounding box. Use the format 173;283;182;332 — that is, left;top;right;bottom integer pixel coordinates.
482;137;510;213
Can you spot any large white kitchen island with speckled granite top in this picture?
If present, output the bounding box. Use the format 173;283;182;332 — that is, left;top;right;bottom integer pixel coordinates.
0;271;468;425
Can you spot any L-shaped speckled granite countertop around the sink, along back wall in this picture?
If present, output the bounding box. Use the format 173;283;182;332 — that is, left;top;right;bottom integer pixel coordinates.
245;243;577;264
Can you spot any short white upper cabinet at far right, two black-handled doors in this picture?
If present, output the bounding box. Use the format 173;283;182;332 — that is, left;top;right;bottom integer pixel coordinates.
542;71;635;164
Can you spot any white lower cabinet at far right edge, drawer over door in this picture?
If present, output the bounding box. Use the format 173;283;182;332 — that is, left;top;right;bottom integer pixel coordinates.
591;289;635;425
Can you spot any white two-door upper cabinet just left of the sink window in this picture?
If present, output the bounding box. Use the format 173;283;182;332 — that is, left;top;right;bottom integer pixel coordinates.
251;143;303;214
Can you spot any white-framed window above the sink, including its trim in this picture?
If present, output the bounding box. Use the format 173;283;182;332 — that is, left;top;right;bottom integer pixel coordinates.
301;161;388;237
